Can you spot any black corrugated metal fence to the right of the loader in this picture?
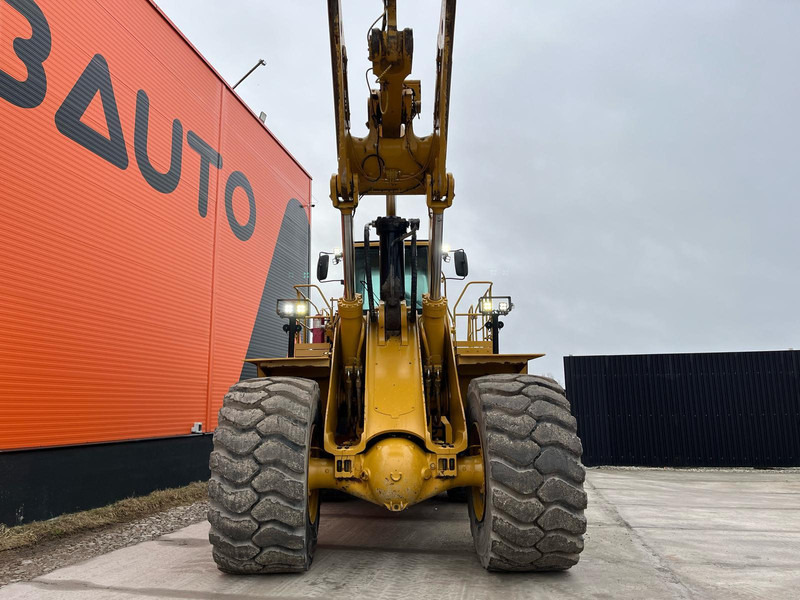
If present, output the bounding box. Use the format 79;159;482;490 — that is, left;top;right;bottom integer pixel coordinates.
564;350;800;467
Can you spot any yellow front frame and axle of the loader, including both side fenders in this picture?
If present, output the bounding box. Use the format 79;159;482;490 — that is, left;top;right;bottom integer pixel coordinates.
247;278;542;511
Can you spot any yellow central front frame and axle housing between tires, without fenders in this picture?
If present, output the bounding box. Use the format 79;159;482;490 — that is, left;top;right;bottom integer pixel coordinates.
308;307;484;511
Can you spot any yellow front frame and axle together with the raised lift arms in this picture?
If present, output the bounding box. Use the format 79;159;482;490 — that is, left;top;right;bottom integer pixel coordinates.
296;0;516;510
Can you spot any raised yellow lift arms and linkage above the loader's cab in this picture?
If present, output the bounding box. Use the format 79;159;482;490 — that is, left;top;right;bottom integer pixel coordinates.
328;0;456;207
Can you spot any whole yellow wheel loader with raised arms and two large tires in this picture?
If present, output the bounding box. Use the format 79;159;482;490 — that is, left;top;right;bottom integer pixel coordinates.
208;0;586;573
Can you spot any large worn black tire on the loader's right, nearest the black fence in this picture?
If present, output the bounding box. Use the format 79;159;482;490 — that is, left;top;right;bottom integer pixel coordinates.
467;375;586;571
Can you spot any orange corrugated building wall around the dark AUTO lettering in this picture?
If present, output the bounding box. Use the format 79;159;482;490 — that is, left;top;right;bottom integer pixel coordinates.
0;0;310;449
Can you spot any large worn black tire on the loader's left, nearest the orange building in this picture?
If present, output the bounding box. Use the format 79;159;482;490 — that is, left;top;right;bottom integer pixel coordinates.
208;377;320;574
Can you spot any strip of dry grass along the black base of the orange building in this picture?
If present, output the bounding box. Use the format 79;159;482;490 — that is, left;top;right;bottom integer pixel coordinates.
0;482;208;552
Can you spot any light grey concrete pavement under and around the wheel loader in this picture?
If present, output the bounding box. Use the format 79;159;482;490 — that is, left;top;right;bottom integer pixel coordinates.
0;469;800;600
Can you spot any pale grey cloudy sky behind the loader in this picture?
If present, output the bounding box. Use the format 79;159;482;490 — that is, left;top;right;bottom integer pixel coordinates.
158;0;800;383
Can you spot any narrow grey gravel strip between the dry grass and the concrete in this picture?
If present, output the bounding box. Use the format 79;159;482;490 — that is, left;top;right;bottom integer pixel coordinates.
0;501;208;586
